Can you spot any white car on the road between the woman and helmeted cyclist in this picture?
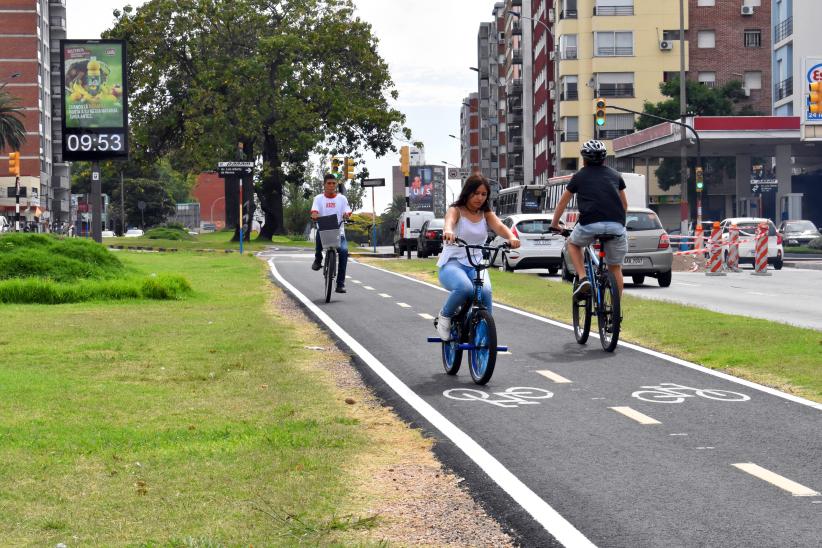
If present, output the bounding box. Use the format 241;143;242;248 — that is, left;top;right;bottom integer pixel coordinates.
491;213;565;275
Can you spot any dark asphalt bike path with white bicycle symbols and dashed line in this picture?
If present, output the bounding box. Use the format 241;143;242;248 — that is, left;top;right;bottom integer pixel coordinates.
270;250;822;547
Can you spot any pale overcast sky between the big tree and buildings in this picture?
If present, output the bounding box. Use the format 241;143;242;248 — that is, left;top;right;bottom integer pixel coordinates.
66;0;494;214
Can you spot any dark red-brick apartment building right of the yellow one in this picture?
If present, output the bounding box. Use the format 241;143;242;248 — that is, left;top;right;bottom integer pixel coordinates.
692;0;772;115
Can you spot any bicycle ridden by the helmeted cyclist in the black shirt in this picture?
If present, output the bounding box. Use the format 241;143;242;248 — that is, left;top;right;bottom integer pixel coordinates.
554;229;622;352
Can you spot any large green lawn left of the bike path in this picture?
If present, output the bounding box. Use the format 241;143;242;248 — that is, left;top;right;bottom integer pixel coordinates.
0;250;426;546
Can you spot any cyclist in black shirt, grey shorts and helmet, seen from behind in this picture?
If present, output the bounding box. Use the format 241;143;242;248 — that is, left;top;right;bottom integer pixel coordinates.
551;140;628;299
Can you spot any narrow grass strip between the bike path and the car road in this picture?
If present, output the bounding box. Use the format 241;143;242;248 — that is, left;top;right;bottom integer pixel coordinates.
358;258;822;402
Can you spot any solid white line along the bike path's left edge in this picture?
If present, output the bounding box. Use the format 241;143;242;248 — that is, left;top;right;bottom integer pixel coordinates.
268;259;596;548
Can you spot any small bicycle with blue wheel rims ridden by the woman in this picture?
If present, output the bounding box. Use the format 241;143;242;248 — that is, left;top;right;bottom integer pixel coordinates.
428;238;509;384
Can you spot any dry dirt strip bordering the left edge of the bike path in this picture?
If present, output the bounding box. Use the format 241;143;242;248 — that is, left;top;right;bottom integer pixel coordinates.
270;280;515;546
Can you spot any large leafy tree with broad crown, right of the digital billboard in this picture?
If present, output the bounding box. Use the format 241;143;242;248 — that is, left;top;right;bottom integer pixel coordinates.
106;0;408;239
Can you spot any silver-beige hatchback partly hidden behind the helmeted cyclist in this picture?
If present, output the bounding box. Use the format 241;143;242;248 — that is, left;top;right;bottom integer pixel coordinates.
562;207;674;287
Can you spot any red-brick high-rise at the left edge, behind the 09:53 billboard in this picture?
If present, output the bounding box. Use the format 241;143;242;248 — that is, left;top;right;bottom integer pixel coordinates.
0;0;70;229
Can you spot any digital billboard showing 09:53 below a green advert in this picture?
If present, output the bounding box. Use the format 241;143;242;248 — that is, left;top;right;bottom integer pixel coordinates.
60;40;128;161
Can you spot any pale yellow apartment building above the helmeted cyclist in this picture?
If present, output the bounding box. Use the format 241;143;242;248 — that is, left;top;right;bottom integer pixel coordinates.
553;0;688;172
